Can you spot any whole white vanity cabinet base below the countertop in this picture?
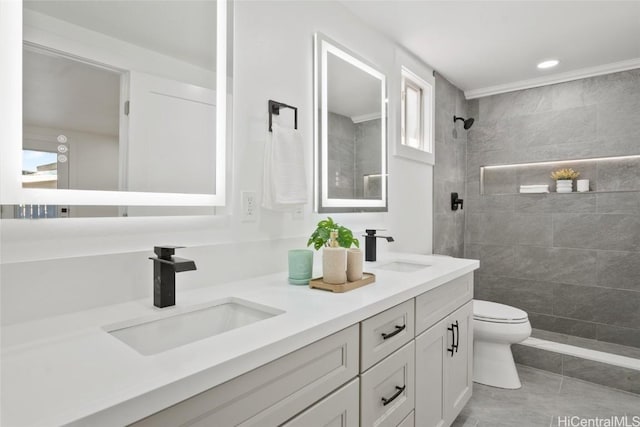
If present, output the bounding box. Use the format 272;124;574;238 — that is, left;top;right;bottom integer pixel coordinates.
129;274;473;427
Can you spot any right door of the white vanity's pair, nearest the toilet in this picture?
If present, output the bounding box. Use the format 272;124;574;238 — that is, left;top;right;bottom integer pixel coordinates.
444;301;473;425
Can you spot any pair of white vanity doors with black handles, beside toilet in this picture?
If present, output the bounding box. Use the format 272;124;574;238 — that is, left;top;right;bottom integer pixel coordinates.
415;301;473;427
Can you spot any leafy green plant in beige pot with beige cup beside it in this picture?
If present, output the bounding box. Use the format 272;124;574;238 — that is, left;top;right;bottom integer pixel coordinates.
307;217;362;285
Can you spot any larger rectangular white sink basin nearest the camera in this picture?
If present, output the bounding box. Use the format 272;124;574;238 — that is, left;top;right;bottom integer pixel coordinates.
104;298;284;356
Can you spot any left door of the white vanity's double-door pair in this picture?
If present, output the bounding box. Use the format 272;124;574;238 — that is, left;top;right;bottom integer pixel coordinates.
415;319;448;427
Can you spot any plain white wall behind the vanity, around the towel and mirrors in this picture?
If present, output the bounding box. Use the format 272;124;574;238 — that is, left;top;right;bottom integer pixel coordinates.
1;1;432;324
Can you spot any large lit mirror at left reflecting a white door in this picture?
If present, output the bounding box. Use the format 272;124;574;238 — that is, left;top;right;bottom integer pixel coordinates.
0;0;229;216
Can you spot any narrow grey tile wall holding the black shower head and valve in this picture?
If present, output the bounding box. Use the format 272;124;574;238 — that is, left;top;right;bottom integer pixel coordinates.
433;75;467;257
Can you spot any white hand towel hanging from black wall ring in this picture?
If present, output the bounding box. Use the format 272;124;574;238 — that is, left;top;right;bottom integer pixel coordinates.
262;123;307;211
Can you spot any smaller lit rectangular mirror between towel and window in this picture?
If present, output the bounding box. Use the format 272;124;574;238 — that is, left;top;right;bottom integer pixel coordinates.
314;33;388;213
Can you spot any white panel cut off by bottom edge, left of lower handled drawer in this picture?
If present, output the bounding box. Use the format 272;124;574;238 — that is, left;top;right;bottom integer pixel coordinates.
283;378;360;427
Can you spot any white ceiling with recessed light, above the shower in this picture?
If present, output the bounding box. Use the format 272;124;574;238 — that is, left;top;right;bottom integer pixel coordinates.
343;0;640;98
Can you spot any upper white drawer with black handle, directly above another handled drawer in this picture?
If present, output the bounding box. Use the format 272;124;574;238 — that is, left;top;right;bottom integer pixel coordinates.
360;300;415;372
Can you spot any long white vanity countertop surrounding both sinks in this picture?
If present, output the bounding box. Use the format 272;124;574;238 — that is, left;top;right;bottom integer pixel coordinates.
0;253;479;427
